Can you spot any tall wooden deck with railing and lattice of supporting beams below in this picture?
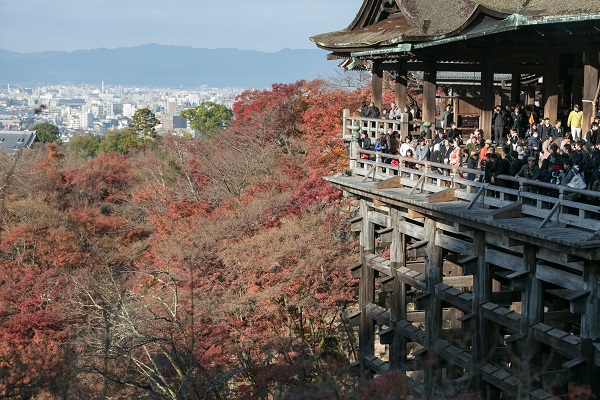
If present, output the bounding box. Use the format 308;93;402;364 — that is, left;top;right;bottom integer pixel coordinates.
326;114;600;399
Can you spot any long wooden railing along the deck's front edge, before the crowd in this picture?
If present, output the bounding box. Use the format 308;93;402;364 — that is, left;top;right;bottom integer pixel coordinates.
351;148;600;233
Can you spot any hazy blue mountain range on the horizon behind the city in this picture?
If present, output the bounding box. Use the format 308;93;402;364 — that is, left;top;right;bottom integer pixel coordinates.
0;44;337;88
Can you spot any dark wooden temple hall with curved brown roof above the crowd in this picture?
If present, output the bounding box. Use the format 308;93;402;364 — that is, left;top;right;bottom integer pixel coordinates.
311;0;600;137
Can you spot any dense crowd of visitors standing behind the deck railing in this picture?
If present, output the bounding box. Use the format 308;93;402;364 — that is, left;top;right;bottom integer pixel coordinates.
359;103;600;197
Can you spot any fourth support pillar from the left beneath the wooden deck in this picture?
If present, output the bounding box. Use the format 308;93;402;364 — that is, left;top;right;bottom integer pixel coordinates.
471;229;492;398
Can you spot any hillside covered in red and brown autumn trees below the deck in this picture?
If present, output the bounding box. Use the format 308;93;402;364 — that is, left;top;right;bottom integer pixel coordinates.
0;81;370;399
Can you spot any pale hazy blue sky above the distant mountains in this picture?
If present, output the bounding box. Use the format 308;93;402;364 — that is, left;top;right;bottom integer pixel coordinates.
0;0;362;53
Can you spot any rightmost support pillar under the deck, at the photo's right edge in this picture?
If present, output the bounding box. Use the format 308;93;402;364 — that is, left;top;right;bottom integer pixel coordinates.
580;261;600;393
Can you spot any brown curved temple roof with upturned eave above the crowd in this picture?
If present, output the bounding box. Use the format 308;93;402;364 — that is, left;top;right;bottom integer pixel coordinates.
311;0;600;51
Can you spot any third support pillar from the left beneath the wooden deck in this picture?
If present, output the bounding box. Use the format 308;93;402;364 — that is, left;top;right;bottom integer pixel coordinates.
424;218;444;399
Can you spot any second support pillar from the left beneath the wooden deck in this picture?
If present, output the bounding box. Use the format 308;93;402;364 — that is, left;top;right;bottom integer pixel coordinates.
389;208;406;370
